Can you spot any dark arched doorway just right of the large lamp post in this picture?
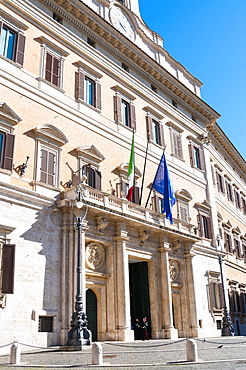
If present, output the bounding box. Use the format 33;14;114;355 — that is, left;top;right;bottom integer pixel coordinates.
86;289;97;342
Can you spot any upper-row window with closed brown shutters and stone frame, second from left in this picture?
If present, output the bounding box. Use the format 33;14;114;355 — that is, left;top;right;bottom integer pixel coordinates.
35;36;69;89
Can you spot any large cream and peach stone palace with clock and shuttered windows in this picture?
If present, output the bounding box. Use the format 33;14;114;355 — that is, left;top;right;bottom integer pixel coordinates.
0;0;246;351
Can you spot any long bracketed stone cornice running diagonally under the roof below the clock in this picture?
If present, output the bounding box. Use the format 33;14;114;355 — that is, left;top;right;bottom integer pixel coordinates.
43;0;220;123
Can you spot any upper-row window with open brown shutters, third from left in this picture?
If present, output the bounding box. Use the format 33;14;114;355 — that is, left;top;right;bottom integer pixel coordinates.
75;62;102;109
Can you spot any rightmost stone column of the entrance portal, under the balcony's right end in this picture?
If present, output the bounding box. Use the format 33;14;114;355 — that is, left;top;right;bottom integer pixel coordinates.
184;245;199;338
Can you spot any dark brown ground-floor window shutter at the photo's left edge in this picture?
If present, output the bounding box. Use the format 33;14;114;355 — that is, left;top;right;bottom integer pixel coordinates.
2;244;15;294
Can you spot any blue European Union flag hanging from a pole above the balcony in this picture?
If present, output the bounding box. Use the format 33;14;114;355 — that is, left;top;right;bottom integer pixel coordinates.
152;153;176;224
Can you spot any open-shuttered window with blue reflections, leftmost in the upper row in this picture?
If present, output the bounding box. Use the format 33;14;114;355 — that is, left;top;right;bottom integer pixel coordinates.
0;17;27;66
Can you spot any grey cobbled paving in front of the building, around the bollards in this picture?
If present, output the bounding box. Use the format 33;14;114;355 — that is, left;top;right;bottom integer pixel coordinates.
0;337;246;370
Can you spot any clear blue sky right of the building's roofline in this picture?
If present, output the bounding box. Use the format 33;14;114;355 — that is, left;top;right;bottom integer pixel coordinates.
139;0;246;158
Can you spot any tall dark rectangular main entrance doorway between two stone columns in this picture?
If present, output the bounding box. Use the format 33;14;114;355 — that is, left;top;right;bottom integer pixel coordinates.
129;262;151;336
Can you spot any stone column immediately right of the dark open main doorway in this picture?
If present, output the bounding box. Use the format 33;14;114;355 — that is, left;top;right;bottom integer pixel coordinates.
158;241;178;339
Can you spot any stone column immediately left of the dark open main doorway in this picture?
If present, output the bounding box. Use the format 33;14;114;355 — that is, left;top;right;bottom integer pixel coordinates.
114;223;134;341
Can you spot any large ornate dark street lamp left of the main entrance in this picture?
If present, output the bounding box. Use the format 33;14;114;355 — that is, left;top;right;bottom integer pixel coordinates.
67;185;90;350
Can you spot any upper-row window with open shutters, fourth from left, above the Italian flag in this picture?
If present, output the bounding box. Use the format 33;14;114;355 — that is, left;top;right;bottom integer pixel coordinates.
114;92;136;129
